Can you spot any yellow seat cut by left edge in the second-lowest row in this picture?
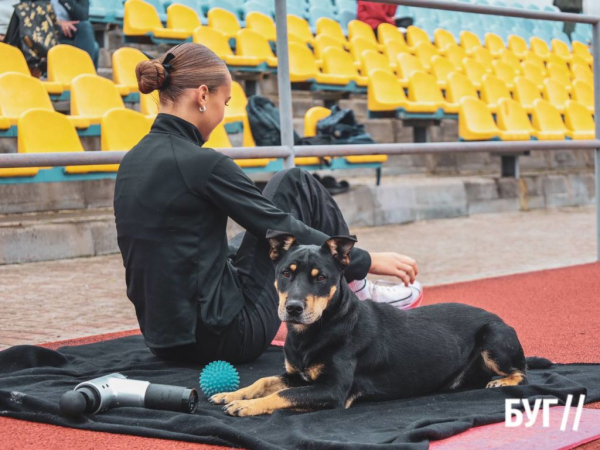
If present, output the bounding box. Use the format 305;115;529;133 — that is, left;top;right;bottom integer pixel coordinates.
0;72;90;130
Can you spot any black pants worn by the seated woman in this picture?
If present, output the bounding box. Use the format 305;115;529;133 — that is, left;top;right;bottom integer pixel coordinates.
153;168;352;364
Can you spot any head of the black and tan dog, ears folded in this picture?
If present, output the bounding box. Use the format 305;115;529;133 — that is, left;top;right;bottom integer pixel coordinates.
267;232;356;325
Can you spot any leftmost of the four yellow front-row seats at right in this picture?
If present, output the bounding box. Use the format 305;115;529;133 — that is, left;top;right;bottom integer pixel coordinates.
458;97;503;141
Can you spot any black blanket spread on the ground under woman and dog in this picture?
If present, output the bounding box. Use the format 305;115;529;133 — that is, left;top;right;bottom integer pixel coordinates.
0;336;600;450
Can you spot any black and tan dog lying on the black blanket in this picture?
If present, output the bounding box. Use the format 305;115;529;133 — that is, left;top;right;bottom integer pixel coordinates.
210;233;526;416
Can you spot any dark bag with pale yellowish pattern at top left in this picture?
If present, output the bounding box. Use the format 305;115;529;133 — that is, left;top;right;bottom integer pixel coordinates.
4;0;58;72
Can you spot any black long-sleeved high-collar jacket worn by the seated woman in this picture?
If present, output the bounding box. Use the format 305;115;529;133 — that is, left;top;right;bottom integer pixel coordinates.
114;114;371;348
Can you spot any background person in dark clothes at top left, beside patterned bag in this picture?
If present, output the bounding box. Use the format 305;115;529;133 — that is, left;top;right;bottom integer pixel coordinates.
52;0;100;68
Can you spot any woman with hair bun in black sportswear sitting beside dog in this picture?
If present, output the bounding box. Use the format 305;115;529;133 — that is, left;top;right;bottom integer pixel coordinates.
114;43;421;363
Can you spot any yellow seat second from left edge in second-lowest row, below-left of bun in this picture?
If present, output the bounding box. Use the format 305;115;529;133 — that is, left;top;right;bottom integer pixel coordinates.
71;75;125;124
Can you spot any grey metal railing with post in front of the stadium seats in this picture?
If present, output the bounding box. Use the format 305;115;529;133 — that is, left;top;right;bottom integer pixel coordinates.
0;0;600;261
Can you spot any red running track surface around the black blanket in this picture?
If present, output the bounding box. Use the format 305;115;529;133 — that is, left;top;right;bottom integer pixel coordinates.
0;264;600;450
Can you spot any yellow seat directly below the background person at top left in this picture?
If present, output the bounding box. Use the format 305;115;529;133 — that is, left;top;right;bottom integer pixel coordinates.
48;44;129;96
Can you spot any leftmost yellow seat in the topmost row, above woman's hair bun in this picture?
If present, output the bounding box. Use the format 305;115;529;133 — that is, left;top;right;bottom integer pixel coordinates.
123;0;192;41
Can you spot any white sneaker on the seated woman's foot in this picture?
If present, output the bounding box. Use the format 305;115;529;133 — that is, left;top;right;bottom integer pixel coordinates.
349;279;423;309
